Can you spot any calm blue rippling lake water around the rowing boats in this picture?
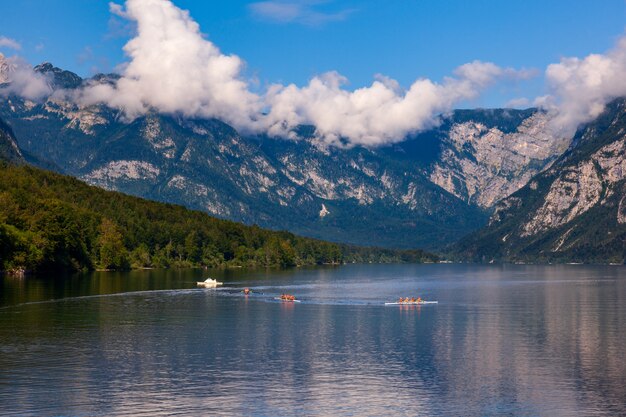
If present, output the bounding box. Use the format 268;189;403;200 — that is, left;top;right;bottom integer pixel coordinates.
0;265;626;416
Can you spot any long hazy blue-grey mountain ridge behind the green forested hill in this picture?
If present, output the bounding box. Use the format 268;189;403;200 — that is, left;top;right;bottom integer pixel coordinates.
0;64;568;249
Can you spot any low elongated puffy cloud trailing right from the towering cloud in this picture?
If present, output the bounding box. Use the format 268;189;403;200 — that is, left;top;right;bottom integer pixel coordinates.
265;61;527;146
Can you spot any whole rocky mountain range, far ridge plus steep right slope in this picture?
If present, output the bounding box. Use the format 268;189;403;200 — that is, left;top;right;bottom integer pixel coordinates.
0;58;626;262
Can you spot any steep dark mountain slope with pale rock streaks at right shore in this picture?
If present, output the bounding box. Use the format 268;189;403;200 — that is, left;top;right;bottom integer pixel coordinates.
457;99;626;263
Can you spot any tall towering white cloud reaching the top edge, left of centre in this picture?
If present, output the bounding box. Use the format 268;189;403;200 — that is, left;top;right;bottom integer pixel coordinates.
80;0;261;128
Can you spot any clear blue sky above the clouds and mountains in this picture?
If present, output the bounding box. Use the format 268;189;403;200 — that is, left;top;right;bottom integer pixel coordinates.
0;0;626;107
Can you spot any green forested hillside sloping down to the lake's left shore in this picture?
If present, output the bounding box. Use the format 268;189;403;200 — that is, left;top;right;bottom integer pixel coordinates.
0;162;428;271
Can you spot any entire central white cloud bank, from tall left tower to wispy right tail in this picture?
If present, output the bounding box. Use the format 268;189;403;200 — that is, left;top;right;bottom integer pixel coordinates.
73;0;533;146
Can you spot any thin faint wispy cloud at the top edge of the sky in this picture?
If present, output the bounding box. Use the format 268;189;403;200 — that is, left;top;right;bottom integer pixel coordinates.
248;0;354;26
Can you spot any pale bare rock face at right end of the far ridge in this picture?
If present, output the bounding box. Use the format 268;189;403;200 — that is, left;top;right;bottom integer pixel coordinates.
430;112;570;208
